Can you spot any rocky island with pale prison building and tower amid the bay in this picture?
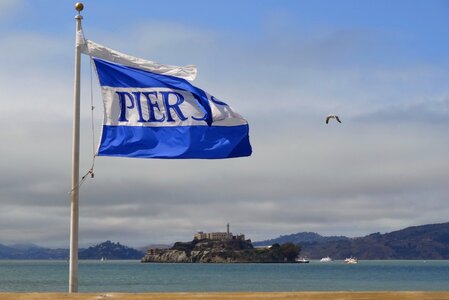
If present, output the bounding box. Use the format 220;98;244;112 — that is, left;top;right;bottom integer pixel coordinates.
141;224;301;263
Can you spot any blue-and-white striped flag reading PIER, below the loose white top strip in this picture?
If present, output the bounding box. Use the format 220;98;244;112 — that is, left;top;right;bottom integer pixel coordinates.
94;58;252;159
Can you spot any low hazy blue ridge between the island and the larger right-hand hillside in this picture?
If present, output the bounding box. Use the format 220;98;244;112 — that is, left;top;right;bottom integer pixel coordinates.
253;232;348;246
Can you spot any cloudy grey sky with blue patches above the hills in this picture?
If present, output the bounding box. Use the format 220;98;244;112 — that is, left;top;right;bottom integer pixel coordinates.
0;0;449;247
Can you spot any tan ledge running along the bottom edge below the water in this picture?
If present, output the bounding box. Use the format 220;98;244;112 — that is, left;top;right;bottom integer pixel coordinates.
0;291;449;300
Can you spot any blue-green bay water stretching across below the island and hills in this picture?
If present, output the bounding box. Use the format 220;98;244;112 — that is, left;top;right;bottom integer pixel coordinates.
0;260;449;292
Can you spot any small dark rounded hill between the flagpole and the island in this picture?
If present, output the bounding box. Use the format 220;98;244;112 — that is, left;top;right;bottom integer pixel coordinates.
78;241;145;259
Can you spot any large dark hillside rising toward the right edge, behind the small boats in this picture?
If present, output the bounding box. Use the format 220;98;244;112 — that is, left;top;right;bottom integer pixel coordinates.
301;223;449;259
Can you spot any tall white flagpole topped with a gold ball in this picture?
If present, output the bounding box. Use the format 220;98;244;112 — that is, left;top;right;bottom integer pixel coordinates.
69;2;84;293
